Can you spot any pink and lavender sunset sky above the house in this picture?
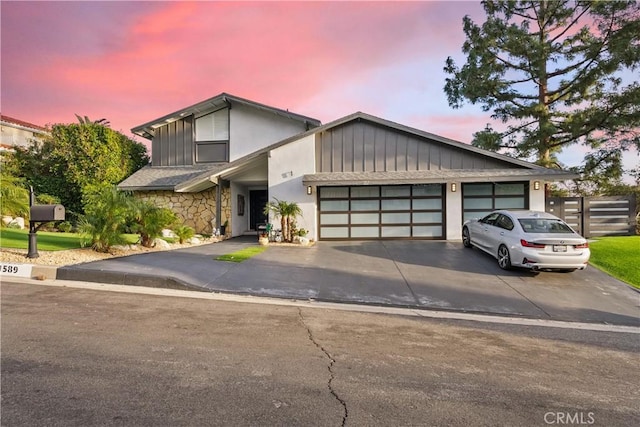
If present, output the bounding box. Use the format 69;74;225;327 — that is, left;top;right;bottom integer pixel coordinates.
0;0;638;177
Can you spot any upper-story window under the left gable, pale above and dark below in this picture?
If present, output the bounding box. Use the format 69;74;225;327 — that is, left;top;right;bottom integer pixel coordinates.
195;108;229;163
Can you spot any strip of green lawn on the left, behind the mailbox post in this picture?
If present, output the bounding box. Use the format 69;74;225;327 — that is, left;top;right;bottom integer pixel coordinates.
0;228;138;251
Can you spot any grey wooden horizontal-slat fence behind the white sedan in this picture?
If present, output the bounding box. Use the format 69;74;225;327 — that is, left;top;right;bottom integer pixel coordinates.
546;194;637;237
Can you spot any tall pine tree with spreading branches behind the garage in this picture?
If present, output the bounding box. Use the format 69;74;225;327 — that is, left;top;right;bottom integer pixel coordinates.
444;0;640;191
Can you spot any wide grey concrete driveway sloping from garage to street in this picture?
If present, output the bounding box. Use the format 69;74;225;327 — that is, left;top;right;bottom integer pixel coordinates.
57;237;640;326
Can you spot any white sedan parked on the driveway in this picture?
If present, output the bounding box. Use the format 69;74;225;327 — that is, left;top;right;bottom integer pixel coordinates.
462;210;591;271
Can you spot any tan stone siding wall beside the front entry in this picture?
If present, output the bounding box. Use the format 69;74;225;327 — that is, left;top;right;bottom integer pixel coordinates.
134;188;231;234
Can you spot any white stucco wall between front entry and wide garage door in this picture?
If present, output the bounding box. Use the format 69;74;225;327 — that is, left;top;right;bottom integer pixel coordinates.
269;135;318;240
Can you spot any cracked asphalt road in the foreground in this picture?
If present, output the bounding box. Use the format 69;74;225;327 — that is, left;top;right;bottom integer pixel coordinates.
1;282;640;426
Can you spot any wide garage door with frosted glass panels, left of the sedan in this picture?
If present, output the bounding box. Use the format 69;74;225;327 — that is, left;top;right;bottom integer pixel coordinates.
318;184;445;240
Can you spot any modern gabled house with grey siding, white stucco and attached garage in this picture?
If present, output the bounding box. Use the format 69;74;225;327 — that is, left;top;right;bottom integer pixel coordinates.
119;93;576;240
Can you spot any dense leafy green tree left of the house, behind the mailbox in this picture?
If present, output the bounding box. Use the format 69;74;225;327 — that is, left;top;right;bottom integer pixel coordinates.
11;116;149;214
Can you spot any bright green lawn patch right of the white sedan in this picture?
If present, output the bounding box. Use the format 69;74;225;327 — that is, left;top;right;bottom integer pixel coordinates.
589;236;640;289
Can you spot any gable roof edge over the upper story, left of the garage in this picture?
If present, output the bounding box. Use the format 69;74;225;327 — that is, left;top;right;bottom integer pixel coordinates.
131;92;321;139
